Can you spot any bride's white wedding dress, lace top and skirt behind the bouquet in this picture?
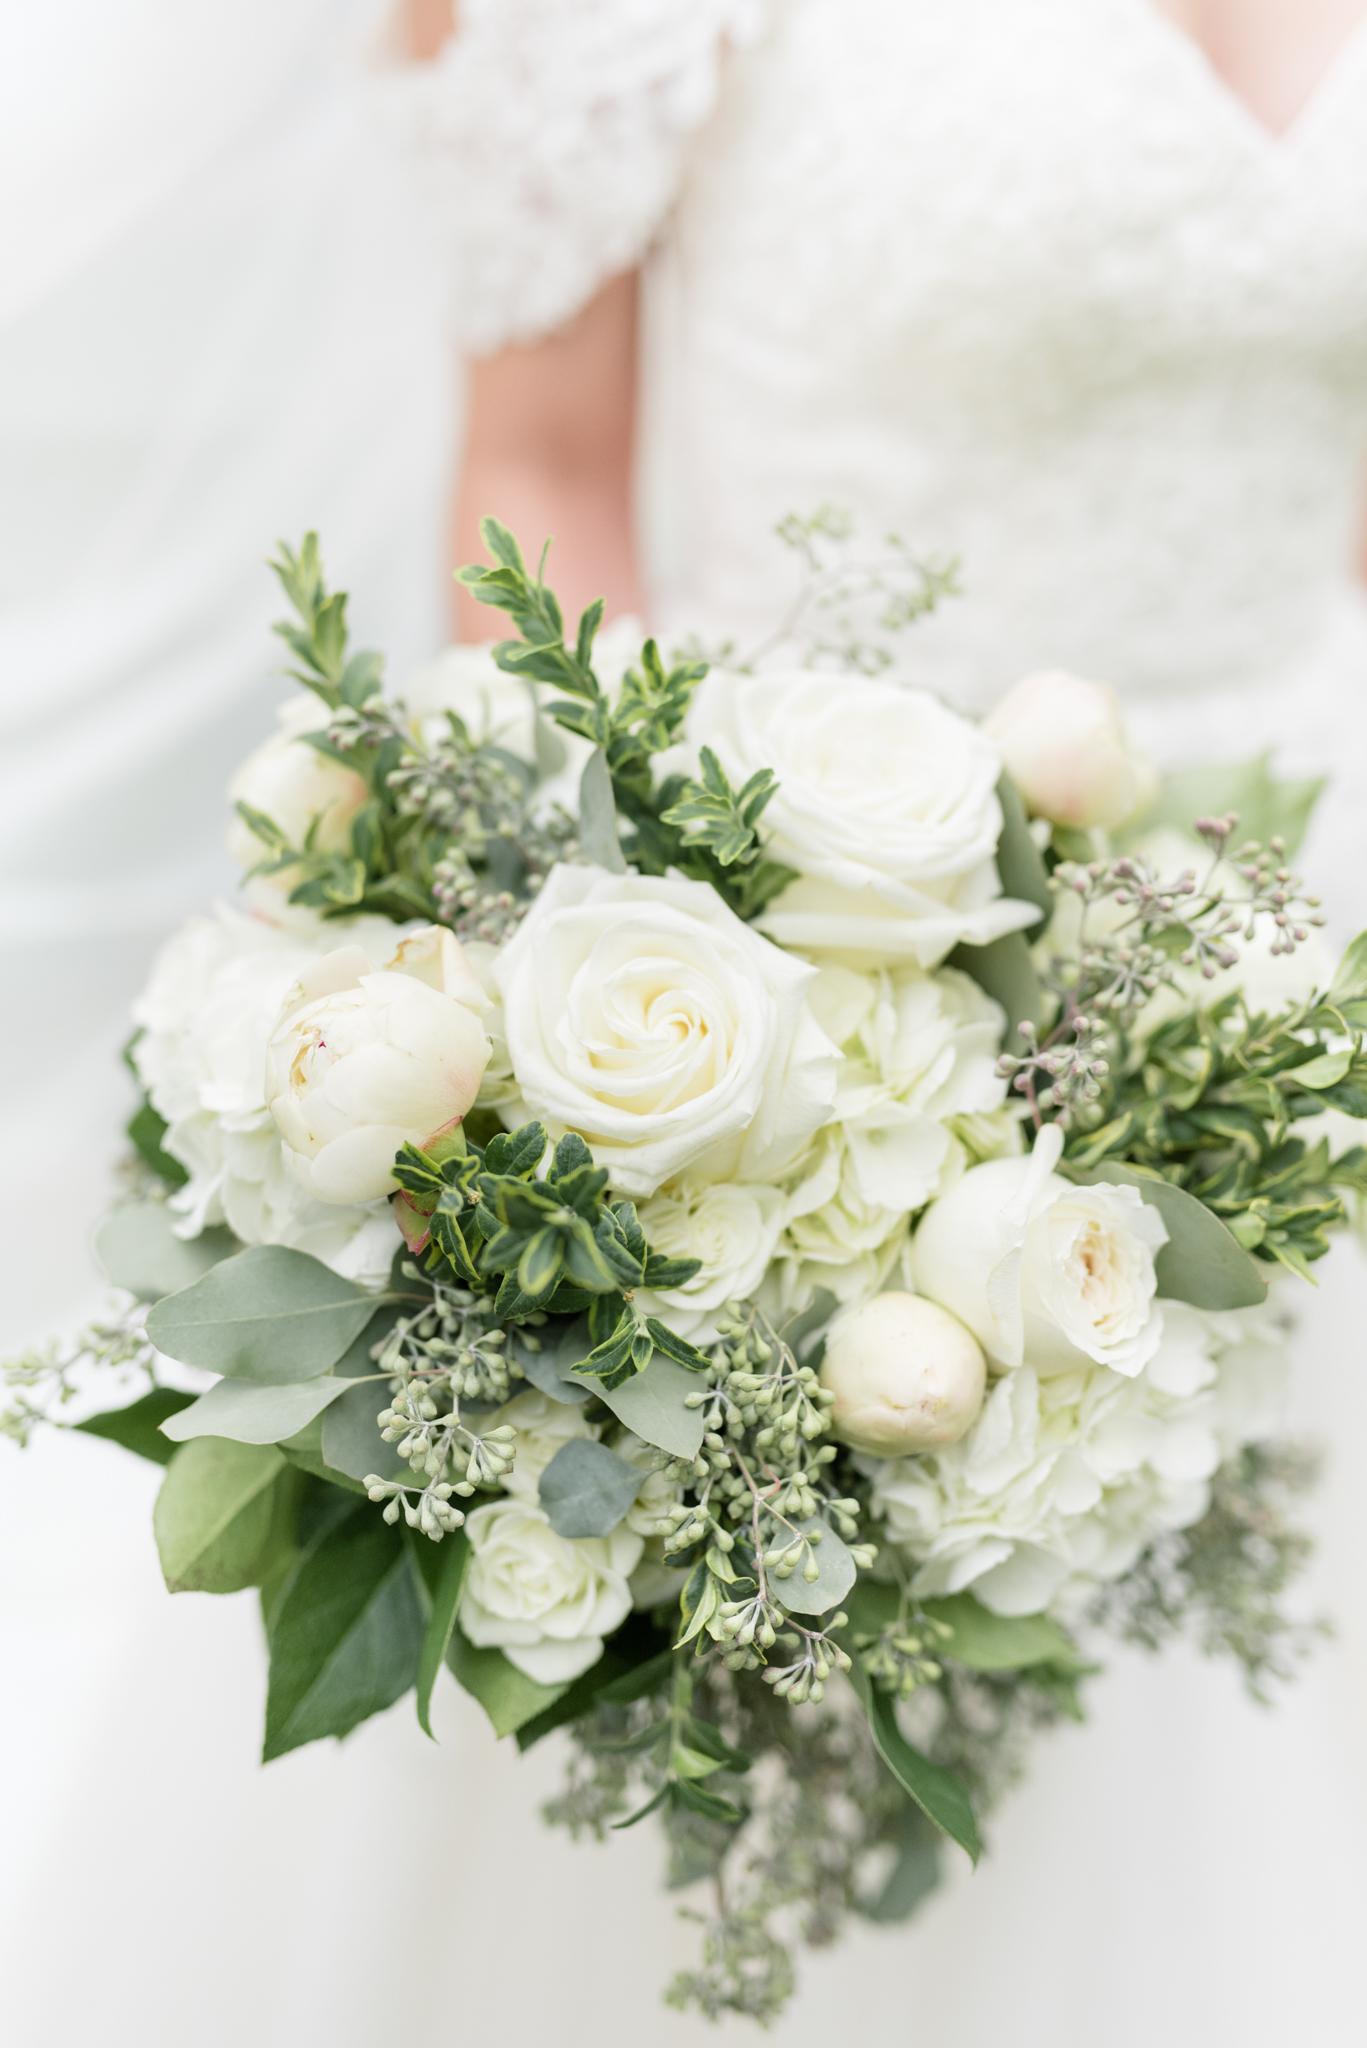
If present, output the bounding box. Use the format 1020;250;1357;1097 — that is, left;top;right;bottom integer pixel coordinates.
10;0;1367;2048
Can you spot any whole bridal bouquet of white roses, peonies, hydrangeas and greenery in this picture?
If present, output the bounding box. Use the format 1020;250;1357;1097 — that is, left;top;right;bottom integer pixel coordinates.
10;520;1367;2019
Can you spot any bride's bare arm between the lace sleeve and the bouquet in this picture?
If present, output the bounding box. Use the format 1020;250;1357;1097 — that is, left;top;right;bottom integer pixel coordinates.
455;270;641;639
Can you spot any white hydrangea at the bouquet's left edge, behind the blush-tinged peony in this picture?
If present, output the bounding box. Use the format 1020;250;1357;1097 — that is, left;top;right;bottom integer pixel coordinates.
133;903;411;1284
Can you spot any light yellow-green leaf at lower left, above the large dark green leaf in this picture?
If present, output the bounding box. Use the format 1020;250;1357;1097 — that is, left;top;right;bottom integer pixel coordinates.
152;1436;301;1593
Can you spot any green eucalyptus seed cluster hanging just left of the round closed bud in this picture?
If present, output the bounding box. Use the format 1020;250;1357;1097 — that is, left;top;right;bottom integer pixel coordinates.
660;1309;875;1700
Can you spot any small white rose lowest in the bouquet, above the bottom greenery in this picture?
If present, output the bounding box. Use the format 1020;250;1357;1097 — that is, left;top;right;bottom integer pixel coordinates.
461;1499;644;1686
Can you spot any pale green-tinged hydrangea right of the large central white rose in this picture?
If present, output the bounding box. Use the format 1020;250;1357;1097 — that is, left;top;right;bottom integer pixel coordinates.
777;965;1019;1309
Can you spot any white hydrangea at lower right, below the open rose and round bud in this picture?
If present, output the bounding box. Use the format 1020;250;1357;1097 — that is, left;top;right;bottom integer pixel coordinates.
865;1300;1287;1614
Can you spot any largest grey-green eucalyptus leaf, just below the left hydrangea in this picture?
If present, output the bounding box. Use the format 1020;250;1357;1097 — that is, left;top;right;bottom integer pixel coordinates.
148;1245;375;1384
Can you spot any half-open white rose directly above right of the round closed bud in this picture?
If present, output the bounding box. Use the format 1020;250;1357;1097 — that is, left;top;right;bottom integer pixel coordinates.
912;1124;1168;1376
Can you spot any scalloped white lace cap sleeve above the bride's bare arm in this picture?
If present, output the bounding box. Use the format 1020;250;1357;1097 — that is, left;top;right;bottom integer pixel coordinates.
379;0;756;354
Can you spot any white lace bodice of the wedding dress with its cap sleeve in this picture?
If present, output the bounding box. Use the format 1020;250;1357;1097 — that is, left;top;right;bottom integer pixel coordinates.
387;0;1367;720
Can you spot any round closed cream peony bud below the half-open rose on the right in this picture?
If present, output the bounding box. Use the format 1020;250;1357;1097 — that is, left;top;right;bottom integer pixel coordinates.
822;1292;988;1458
